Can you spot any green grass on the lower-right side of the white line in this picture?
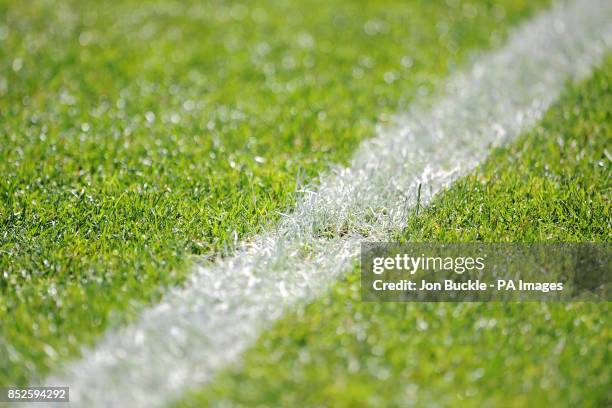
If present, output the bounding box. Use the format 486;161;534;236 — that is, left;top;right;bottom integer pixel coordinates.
177;59;612;407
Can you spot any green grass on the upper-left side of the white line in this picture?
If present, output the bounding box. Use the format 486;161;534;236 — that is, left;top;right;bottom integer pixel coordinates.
0;0;547;385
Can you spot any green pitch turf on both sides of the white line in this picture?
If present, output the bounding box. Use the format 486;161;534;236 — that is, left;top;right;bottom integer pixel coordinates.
0;1;612;406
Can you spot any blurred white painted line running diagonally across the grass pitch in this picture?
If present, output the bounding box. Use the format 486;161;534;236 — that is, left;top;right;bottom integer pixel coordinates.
44;0;612;407
